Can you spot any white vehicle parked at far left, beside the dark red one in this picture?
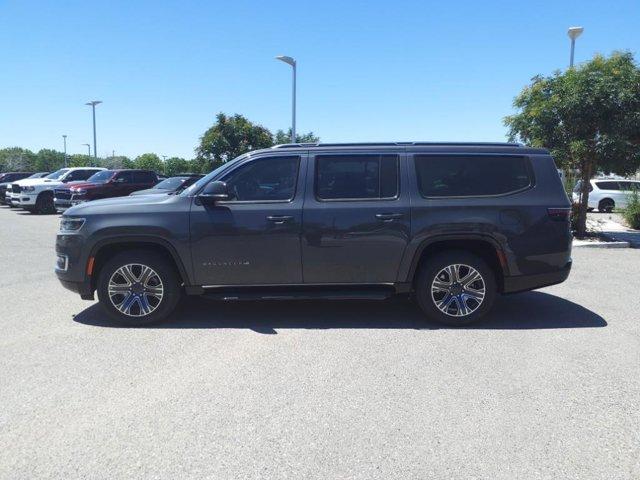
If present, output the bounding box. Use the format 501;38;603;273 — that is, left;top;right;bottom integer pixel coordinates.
10;167;106;213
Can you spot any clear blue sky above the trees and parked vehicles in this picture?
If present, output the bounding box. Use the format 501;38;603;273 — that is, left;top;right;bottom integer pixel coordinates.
0;0;640;158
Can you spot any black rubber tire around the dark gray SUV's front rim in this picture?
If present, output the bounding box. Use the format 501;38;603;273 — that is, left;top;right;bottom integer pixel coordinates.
97;250;182;326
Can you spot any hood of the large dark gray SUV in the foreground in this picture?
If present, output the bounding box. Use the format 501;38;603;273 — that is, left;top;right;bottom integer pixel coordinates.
65;195;181;215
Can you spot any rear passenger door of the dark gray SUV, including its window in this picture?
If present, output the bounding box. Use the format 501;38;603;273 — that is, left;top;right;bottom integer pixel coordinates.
302;152;411;284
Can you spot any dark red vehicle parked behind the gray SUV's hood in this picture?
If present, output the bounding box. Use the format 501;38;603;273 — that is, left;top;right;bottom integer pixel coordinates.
54;170;158;210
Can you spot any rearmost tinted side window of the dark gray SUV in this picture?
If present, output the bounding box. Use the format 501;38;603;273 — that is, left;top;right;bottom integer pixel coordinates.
414;155;532;197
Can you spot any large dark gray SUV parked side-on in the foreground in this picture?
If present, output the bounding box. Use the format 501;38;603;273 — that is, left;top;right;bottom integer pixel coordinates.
56;142;571;325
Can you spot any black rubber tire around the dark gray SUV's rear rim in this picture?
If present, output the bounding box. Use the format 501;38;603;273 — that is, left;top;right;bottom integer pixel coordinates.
415;250;497;327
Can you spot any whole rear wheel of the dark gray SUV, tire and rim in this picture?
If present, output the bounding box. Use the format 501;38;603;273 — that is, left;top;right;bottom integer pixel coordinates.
416;250;496;326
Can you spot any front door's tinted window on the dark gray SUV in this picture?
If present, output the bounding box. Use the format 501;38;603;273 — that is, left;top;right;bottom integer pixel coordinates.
222;157;300;201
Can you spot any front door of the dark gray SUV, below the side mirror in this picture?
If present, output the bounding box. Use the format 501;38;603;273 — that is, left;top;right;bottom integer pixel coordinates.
190;154;307;285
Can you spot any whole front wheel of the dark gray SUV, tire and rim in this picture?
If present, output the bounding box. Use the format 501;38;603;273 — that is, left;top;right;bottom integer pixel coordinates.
97;250;181;326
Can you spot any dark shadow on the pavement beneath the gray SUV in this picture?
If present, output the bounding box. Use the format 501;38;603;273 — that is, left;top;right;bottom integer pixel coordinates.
74;292;607;334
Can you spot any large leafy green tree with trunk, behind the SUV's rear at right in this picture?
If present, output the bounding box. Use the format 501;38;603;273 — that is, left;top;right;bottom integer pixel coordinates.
505;52;640;236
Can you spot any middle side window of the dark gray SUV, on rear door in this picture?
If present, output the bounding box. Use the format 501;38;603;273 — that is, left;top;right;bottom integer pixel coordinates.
316;155;398;200
